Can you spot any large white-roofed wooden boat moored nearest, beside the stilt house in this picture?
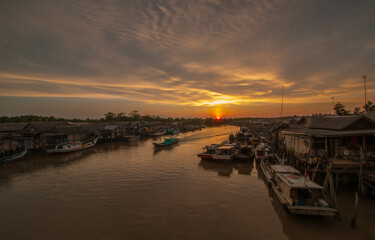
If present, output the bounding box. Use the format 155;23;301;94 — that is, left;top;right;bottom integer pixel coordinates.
260;160;337;216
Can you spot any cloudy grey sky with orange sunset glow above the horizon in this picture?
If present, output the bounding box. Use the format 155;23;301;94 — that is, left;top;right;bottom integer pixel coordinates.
0;0;375;118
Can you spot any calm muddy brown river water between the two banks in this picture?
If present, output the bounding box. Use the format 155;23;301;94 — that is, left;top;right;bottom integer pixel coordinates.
0;126;375;240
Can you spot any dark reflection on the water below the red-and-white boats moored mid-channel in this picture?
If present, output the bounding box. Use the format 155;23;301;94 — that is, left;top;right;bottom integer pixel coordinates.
199;160;254;177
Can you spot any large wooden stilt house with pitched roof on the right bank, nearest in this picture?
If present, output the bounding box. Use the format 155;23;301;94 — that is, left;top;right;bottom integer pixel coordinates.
281;115;375;159
